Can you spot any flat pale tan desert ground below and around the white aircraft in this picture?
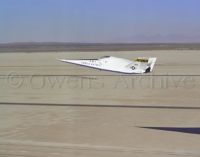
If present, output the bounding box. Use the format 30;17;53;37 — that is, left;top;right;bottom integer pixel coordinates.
0;50;200;157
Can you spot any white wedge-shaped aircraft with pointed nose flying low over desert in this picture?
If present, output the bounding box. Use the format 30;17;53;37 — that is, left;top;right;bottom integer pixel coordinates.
59;56;157;74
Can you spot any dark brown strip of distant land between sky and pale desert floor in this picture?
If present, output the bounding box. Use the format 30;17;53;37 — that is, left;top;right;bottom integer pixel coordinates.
0;42;200;53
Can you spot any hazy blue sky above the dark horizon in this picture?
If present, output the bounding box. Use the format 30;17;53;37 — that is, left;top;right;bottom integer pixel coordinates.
0;0;200;42
